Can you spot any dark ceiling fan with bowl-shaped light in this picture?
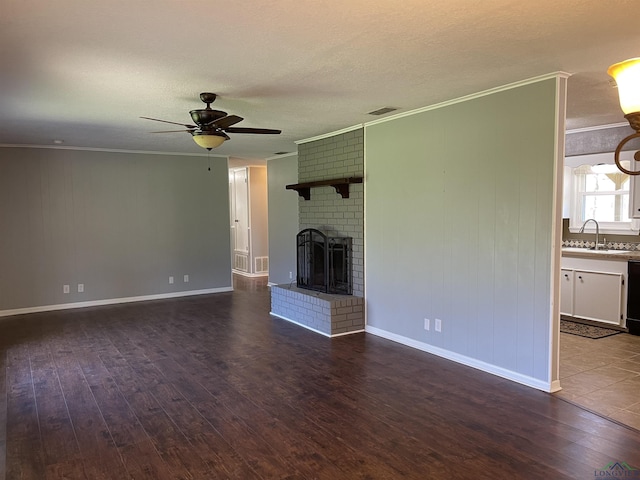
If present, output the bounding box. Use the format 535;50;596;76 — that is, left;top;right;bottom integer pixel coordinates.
140;92;281;150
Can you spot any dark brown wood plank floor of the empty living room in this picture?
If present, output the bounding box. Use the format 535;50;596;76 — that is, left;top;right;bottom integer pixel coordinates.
0;280;640;480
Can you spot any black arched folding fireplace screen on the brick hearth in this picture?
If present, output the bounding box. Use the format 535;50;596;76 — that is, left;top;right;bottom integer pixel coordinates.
296;228;353;295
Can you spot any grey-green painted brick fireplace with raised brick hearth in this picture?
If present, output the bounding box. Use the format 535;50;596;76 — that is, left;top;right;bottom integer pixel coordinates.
271;128;365;336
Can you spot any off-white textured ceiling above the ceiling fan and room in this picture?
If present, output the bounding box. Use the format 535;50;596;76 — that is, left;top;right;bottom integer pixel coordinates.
0;0;640;158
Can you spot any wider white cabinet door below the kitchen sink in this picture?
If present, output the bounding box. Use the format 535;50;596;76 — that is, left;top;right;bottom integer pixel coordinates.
573;270;623;325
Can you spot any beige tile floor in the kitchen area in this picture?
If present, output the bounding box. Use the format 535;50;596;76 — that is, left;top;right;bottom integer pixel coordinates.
555;333;640;430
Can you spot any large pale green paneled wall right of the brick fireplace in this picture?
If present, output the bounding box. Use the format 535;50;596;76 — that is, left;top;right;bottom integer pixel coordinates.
365;78;564;390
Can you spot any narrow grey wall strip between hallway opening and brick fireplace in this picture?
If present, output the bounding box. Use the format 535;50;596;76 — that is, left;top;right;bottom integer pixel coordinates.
267;155;299;284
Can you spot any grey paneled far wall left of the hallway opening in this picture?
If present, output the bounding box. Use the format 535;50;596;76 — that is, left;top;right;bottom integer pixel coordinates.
0;147;231;314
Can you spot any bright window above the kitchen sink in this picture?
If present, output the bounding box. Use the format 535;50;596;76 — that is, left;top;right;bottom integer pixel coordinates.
565;155;638;234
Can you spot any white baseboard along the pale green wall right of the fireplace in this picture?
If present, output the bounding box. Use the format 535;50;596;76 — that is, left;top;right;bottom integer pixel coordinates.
365;325;554;393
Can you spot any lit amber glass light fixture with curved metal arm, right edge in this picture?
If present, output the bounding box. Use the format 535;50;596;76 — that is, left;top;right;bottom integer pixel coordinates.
607;58;640;175
